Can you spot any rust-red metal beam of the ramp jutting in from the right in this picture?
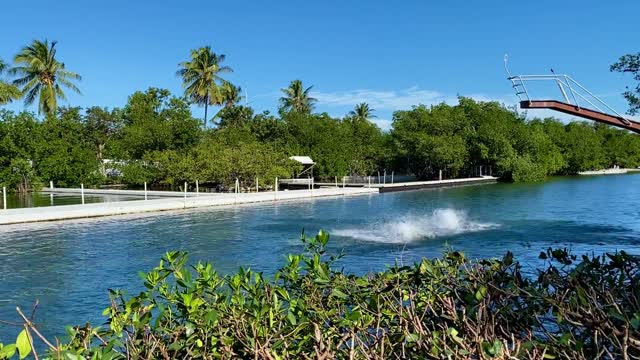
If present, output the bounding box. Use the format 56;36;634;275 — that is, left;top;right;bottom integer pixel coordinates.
520;100;640;133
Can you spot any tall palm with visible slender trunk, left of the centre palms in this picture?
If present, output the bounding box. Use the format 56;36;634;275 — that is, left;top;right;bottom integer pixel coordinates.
176;46;233;127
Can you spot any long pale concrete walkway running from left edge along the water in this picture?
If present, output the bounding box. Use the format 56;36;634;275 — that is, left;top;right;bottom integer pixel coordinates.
0;188;378;225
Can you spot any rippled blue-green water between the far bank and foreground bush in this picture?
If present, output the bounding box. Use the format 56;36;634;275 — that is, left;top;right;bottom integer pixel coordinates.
0;175;640;341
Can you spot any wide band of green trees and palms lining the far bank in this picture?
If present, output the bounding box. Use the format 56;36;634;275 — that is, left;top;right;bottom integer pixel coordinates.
0;41;640;191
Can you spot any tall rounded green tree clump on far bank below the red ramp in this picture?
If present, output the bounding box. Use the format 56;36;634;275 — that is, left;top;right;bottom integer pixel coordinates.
391;98;640;181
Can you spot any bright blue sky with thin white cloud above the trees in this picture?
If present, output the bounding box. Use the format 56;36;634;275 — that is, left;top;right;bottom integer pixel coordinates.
0;0;640;128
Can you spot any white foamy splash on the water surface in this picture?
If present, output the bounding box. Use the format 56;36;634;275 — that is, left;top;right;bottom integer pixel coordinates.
331;209;497;244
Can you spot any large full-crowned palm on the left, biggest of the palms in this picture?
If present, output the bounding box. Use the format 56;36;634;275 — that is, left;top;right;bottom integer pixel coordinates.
9;40;82;114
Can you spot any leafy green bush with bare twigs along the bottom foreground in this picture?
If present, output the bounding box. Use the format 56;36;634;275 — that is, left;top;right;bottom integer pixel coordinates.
0;232;640;359
